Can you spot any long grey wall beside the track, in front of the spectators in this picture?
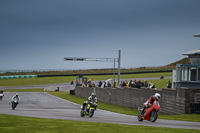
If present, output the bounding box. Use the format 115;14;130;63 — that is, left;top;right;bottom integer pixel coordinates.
75;87;200;115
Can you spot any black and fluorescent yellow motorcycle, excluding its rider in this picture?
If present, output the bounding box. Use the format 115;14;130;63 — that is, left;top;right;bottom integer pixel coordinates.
80;102;97;117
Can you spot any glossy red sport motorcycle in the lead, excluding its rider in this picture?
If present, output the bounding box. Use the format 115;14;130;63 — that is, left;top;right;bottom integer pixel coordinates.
138;100;160;122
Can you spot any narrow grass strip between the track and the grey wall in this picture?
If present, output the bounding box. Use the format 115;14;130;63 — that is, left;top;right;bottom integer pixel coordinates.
48;92;200;122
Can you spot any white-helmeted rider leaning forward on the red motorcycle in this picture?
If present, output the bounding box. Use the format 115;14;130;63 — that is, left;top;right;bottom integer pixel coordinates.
142;93;161;115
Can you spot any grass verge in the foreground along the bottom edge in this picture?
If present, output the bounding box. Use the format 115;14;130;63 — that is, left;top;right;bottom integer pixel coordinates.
0;114;199;133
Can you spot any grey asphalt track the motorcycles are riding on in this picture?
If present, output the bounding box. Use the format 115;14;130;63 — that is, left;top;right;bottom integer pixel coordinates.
0;92;200;129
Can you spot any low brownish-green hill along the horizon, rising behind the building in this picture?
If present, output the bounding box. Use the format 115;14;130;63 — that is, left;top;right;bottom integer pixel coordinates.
0;57;191;76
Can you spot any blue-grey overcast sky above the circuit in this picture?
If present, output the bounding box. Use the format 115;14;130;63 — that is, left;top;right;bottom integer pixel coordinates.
0;0;200;70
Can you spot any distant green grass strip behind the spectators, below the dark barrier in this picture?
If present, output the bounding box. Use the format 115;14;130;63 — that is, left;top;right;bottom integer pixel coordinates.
0;72;172;88
